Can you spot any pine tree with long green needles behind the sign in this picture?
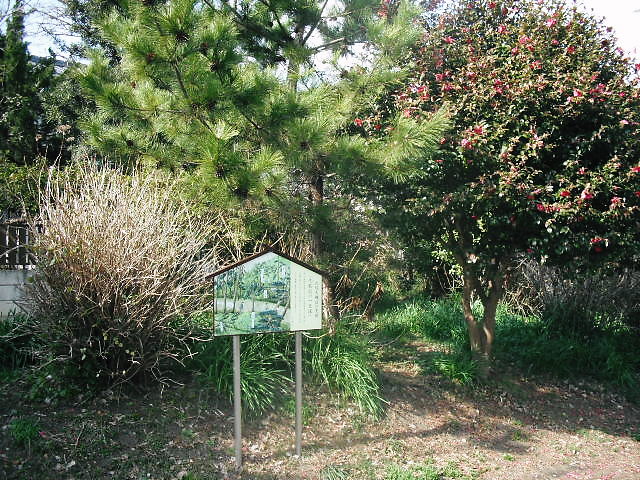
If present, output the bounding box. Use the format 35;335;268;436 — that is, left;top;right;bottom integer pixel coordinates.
77;0;439;322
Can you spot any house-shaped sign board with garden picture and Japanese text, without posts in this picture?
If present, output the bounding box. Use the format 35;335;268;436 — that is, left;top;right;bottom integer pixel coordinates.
214;252;322;336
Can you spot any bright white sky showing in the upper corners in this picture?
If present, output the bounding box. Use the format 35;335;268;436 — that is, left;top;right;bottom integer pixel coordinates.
20;0;640;60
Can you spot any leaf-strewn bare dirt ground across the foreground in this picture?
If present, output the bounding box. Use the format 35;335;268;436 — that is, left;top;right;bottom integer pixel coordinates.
0;344;640;480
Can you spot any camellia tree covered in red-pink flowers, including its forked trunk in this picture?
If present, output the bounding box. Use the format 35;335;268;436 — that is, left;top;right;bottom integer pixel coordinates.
367;0;640;375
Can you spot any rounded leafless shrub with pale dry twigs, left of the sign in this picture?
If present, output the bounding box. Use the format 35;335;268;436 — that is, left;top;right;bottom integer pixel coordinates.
26;169;233;385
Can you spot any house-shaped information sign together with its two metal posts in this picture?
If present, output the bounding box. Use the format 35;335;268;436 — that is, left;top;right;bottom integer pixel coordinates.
211;250;323;470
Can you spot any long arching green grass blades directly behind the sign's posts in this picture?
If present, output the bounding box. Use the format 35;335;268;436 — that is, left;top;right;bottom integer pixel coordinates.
189;329;382;416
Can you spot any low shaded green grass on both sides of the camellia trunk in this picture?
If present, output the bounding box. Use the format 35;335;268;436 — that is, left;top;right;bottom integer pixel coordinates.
376;295;640;399
